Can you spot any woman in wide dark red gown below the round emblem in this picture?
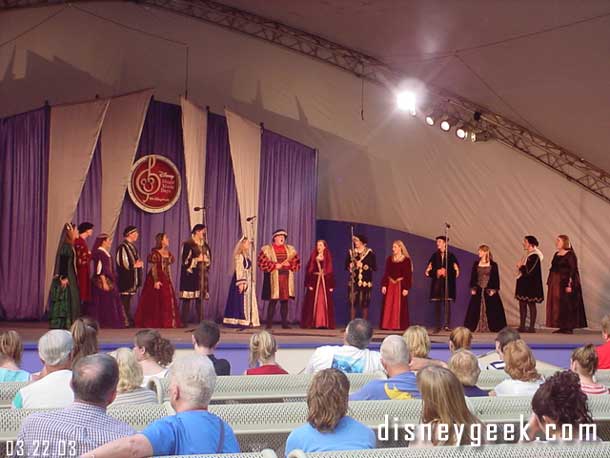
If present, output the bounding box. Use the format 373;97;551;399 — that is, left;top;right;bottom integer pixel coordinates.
135;232;181;328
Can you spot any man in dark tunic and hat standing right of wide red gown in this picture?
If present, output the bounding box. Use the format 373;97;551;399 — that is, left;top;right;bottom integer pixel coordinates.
180;224;212;326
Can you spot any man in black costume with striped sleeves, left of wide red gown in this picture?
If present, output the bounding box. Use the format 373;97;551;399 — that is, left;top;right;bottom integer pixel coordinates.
116;226;144;326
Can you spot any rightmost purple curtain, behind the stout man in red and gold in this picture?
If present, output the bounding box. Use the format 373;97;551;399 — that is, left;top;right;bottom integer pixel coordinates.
257;130;318;321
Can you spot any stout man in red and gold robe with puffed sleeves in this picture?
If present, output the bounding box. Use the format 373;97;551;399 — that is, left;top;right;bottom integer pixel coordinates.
258;229;301;329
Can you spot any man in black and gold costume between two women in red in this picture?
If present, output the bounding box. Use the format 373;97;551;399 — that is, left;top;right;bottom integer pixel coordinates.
345;235;377;320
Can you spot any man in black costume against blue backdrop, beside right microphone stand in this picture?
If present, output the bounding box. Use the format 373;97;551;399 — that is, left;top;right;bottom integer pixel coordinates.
426;235;460;332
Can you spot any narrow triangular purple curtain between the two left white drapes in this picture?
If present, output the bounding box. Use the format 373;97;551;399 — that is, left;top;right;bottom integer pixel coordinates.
72;139;102;233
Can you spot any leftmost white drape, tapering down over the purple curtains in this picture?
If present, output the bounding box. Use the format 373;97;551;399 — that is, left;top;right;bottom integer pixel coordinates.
45;100;109;306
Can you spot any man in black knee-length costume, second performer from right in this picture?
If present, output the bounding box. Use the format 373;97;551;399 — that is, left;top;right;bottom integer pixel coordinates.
515;235;544;332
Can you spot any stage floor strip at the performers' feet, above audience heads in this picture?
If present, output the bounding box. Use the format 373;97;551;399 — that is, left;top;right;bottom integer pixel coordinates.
0;321;601;348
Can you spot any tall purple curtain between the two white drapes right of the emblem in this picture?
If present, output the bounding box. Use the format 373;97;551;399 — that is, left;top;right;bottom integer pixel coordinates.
205;113;242;320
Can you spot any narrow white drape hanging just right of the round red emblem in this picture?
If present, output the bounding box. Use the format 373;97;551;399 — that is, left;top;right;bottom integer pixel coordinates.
180;97;208;227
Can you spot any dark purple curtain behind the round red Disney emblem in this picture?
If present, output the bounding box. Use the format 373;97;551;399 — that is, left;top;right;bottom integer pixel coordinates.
113;100;191;313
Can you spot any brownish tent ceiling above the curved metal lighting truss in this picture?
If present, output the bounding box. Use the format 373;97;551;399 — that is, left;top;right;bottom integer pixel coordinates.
222;0;610;171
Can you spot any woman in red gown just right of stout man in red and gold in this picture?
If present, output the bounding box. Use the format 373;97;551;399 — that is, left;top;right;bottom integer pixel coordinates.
301;240;335;329
